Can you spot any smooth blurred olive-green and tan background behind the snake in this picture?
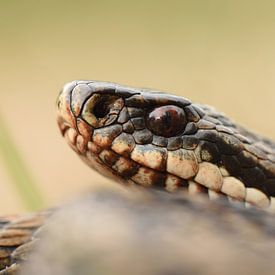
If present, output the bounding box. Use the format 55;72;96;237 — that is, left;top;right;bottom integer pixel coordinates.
0;0;275;215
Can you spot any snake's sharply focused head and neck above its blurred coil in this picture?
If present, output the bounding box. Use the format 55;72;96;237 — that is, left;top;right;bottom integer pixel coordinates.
57;81;275;211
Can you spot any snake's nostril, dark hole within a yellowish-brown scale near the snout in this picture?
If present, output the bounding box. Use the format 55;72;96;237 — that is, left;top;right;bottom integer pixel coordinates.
81;94;124;128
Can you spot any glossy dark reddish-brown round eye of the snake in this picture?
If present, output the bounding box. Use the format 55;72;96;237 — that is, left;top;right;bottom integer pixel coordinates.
146;105;187;137
